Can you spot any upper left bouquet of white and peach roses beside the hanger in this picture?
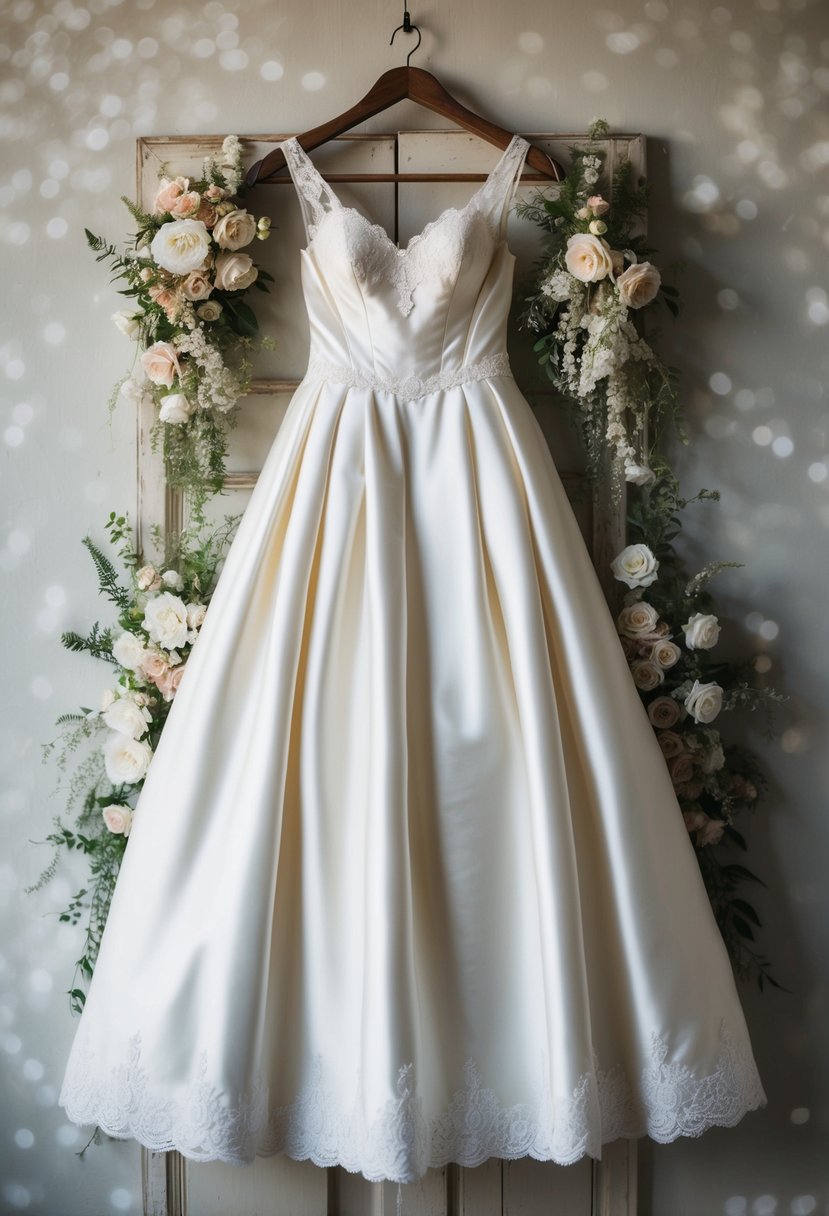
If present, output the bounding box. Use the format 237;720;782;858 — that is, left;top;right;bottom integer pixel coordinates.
84;135;273;519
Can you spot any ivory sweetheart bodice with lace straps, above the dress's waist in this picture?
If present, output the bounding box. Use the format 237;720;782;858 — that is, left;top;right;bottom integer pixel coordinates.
281;135;529;396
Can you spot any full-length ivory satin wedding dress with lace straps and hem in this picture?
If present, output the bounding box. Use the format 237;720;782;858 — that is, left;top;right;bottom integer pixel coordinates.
60;136;766;1182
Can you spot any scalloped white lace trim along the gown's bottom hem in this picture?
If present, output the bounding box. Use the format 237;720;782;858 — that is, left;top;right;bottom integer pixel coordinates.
60;1023;767;1182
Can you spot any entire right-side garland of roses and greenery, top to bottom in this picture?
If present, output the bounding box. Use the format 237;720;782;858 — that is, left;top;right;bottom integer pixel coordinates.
518;120;784;989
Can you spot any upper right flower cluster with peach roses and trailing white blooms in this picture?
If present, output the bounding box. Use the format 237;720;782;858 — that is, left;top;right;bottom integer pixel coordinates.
517;119;686;501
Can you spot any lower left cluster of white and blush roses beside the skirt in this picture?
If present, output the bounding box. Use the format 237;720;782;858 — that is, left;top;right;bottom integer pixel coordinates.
30;512;238;1012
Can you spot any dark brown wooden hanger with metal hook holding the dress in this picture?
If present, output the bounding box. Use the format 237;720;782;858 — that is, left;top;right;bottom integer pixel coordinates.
244;11;565;186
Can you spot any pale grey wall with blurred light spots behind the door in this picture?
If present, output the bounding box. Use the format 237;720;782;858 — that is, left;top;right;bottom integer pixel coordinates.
0;0;829;1216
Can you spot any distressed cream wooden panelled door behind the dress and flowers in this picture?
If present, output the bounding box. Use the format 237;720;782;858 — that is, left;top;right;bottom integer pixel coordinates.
136;130;645;1216
